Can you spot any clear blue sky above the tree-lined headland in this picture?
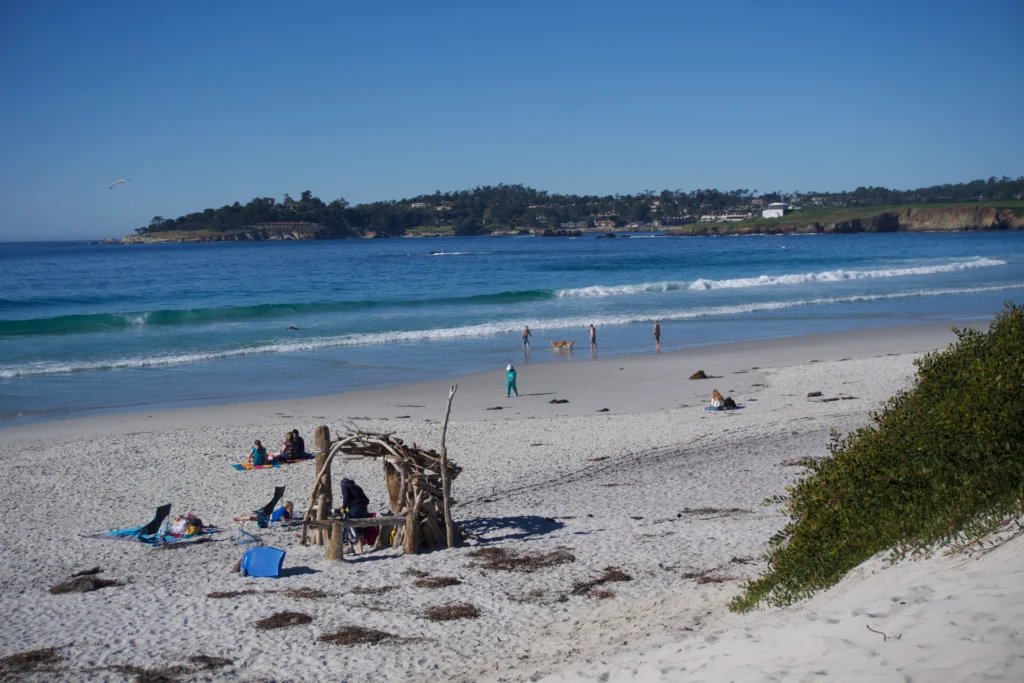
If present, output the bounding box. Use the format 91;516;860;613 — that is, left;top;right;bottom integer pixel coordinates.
0;0;1024;241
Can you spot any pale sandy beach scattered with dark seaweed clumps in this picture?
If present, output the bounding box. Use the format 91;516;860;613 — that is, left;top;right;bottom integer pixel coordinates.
0;325;1024;681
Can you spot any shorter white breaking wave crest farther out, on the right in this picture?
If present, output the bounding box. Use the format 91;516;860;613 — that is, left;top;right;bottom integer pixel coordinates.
555;256;1007;299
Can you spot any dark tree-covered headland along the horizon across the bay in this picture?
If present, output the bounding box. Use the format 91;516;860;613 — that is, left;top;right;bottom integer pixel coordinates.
135;177;1024;239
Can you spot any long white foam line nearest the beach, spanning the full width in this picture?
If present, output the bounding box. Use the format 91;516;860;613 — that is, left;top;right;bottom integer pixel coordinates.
0;283;1024;379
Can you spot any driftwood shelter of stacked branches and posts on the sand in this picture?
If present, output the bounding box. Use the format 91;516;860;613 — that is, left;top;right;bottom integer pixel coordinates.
302;387;465;560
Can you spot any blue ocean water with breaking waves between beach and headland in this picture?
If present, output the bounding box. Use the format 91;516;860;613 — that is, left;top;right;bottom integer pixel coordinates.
0;232;1024;425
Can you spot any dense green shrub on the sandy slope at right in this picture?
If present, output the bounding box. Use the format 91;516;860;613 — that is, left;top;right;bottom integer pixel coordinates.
731;303;1024;611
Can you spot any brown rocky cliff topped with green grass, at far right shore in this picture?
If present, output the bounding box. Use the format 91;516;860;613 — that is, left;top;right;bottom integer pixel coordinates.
668;205;1024;237
